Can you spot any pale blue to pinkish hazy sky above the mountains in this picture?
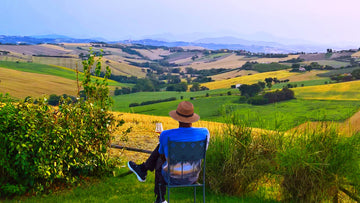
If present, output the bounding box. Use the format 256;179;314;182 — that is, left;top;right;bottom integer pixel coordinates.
0;0;360;46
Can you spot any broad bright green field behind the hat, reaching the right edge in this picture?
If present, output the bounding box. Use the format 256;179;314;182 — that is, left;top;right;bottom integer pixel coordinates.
113;93;360;130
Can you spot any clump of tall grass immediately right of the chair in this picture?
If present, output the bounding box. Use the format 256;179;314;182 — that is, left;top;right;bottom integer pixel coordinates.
206;113;282;195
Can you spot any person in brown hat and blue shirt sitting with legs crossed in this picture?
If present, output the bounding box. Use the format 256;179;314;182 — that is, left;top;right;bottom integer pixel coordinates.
127;101;210;203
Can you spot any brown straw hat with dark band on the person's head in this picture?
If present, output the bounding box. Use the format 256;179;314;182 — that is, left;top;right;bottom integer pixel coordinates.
169;101;200;123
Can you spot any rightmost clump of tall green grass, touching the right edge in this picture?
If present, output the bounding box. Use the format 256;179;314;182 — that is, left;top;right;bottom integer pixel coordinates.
274;123;360;202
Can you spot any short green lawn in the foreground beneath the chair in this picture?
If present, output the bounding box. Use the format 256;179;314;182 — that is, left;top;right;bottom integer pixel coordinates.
4;164;276;203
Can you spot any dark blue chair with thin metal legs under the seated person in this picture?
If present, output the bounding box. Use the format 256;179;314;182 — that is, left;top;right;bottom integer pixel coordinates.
159;139;207;203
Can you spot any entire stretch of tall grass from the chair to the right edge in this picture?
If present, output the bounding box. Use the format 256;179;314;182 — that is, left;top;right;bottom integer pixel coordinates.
206;111;360;202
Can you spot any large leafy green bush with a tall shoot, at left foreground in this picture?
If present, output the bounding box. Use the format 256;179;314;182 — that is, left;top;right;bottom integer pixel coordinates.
0;49;114;197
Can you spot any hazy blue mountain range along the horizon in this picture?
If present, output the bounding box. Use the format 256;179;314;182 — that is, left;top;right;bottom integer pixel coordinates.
0;33;346;53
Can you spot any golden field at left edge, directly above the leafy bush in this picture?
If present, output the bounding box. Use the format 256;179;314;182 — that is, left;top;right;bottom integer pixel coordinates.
0;68;77;98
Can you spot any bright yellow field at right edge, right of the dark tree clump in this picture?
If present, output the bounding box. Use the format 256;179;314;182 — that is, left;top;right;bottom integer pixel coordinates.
293;80;360;100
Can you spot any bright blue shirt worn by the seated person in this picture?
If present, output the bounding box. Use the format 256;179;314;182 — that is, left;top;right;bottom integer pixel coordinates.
159;127;210;184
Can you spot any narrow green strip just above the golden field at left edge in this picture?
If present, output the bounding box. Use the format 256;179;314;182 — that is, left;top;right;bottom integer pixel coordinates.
0;61;129;87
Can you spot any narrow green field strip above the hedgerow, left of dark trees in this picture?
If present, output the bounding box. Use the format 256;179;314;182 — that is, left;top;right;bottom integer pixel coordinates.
113;89;240;112
